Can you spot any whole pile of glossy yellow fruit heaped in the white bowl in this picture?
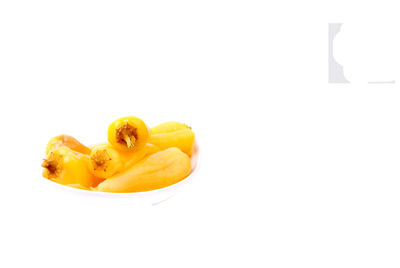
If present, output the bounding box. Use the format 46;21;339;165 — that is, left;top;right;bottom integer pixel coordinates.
42;116;194;193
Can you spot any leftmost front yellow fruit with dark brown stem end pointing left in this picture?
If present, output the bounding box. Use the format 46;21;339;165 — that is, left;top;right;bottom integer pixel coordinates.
42;146;101;188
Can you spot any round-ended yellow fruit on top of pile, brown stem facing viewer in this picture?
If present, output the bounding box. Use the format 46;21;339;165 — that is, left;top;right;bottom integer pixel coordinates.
107;116;150;152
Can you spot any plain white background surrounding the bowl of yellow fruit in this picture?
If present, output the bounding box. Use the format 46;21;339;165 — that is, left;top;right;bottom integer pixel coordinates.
0;0;400;268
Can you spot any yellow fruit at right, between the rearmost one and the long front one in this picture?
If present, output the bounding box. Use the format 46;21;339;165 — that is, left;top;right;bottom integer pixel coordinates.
149;128;194;156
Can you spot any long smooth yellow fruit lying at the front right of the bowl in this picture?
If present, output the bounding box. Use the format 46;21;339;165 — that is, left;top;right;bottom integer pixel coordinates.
97;148;190;193
